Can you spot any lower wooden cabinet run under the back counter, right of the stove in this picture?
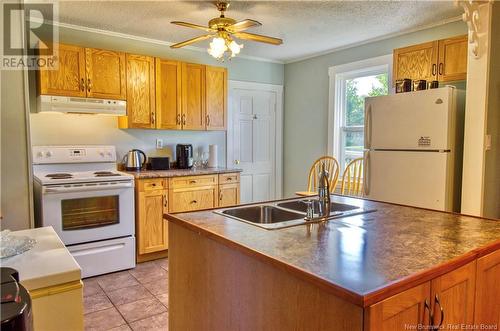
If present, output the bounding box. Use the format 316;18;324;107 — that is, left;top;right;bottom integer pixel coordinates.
135;173;240;262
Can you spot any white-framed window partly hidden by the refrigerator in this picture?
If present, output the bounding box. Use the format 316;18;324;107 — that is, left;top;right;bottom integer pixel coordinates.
328;56;392;169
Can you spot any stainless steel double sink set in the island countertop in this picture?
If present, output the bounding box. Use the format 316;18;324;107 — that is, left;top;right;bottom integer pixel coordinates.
214;199;373;230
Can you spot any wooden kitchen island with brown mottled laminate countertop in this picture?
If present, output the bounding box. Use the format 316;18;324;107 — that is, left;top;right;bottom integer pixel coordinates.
166;195;500;331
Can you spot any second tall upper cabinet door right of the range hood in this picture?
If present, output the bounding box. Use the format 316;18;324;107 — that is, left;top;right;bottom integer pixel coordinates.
156;59;182;129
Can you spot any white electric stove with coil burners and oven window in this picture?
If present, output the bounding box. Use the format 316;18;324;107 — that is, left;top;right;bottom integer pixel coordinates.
32;146;135;277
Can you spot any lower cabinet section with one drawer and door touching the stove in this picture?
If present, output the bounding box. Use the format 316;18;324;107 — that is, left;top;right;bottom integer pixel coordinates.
136;178;168;260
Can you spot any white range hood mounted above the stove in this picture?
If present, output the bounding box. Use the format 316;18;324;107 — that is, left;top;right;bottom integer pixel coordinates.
37;95;127;116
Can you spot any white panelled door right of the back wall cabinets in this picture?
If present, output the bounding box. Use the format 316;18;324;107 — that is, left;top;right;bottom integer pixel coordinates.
227;87;277;203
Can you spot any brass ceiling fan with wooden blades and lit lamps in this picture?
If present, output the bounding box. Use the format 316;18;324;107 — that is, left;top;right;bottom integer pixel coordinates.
170;1;283;59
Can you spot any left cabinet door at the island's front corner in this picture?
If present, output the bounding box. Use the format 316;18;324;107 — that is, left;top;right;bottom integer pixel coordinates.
365;282;430;331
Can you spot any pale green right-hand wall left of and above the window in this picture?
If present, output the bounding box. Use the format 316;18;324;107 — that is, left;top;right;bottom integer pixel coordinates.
283;21;467;196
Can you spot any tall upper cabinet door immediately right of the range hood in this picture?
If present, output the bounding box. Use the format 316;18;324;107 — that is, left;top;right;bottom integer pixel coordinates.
127;54;156;129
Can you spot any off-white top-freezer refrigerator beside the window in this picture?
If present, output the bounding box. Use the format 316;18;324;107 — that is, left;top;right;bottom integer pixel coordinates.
363;86;465;211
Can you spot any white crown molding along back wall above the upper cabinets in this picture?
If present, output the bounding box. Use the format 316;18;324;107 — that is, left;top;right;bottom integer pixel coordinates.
29;17;284;64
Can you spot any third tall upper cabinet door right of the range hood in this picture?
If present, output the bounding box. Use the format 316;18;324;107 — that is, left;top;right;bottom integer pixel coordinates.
182;63;205;130
